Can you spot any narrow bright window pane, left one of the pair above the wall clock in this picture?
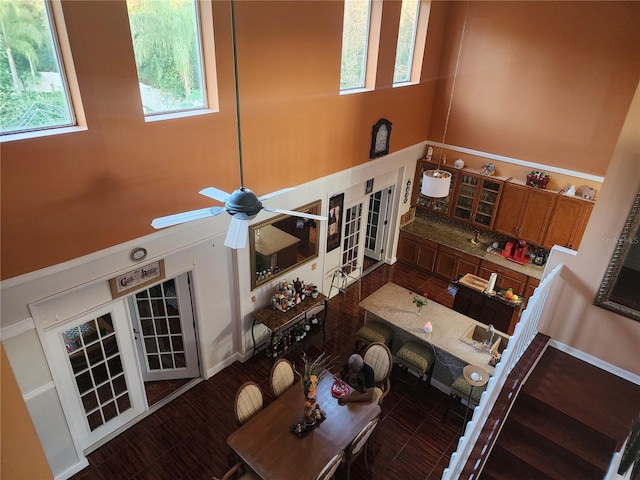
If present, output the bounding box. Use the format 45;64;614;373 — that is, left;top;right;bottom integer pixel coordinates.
340;0;371;90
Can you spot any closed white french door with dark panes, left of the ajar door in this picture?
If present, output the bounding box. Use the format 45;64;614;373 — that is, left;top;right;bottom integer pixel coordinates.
46;301;146;449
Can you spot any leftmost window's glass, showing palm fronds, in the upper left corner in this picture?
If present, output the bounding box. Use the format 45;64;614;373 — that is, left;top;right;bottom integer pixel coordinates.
0;0;75;135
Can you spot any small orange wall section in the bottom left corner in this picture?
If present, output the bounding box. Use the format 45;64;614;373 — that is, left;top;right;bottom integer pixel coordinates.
0;343;53;480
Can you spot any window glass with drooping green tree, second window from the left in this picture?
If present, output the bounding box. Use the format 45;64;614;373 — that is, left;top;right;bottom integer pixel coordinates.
127;0;206;115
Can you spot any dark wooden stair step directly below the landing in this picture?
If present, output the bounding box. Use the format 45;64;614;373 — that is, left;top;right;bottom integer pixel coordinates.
508;392;617;475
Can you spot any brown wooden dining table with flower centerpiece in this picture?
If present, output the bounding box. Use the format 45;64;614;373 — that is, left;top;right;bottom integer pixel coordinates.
227;372;380;480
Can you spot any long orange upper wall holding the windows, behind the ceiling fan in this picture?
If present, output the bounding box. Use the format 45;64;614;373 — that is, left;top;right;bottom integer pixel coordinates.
1;0;439;279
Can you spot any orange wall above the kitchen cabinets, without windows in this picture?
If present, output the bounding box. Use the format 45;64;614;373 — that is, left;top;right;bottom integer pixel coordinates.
429;1;640;177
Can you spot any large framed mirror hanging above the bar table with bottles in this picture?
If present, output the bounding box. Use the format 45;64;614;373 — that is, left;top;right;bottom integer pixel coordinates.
249;200;322;290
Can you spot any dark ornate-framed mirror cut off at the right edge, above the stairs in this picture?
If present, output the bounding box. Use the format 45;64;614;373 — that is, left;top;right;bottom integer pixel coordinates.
593;192;640;321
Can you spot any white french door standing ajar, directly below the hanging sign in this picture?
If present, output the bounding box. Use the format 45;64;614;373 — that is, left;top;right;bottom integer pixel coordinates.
128;273;200;382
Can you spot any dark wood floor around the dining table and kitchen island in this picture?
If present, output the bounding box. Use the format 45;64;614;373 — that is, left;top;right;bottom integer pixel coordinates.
72;264;462;480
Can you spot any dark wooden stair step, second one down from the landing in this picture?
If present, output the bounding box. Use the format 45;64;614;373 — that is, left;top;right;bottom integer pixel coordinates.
498;420;606;480
